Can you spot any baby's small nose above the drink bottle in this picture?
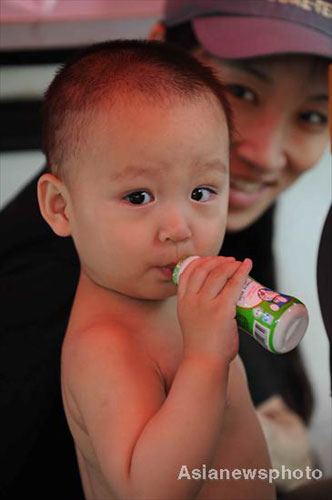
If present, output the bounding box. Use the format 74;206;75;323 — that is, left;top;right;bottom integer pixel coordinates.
158;210;192;243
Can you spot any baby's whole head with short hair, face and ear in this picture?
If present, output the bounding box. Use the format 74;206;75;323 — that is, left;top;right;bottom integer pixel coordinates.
38;40;232;298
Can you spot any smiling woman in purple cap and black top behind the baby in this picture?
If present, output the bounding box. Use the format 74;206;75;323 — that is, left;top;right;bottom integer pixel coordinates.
0;0;331;499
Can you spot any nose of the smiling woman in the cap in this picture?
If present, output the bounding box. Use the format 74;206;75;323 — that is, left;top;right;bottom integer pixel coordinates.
236;123;287;172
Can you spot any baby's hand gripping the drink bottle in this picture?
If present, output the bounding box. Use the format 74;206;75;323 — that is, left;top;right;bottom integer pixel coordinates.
178;257;252;362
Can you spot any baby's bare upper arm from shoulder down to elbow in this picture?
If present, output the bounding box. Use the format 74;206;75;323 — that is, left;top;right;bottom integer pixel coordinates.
61;321;166;496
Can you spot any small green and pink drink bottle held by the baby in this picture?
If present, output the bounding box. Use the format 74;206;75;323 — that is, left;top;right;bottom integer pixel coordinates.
172;255;309;354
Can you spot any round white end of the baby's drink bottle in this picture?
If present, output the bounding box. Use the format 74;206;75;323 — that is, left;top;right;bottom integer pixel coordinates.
273;304;309;354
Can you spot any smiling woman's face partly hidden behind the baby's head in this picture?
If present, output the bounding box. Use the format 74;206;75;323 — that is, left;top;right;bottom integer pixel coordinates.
196;49;328;231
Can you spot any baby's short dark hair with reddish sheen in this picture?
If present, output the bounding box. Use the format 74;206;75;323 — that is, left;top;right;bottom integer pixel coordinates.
42;40;233;179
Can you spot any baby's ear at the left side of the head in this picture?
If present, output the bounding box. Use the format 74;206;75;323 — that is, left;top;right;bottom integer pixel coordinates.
37;174;71;236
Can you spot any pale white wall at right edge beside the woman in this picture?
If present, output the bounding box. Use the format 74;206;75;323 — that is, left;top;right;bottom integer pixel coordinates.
275;152;332;475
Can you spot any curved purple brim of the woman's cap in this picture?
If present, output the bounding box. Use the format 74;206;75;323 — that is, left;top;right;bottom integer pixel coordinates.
192;16;332;59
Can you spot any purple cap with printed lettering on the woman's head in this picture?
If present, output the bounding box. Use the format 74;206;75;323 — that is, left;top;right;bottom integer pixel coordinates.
164;0;332;58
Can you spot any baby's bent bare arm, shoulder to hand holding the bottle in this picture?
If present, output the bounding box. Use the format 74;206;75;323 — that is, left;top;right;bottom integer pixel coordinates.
64;258;256;500
